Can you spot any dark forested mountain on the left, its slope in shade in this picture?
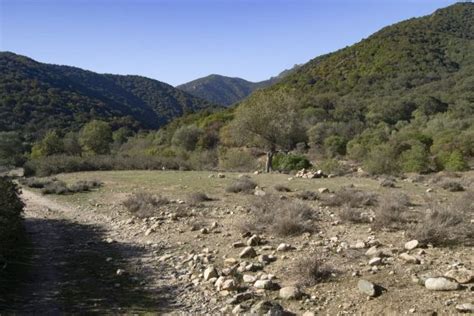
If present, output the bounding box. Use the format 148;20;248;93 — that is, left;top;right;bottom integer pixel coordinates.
0;52;212;134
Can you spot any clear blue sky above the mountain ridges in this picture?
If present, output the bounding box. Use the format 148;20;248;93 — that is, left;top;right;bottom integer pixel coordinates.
0;0;455;85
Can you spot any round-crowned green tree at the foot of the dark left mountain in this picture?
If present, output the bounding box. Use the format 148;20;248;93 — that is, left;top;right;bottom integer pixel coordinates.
79;120;112;155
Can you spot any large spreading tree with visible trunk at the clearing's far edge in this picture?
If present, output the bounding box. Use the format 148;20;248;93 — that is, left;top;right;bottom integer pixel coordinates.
231;93;306;172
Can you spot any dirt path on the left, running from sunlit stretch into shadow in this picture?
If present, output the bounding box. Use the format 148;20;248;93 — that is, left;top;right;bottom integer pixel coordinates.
5;190;180;314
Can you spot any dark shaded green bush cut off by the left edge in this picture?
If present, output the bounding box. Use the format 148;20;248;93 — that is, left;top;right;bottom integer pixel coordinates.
0;177;24;266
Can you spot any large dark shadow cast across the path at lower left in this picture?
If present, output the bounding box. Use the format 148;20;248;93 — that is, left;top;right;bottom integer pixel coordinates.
0;219;177;314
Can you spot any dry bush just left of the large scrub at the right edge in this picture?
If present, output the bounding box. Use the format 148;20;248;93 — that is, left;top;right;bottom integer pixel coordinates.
372;193;411;229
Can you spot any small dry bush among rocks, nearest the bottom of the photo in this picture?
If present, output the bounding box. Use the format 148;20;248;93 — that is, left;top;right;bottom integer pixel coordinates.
292;254;336;286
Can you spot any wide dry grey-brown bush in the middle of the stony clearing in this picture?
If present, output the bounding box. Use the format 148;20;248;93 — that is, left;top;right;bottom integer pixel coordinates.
240;195;315;236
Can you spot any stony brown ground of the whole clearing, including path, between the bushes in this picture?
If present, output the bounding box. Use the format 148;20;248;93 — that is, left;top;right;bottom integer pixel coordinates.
0;172;474;315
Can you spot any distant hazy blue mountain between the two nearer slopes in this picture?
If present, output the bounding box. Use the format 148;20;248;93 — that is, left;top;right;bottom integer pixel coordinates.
176;65;299;106
